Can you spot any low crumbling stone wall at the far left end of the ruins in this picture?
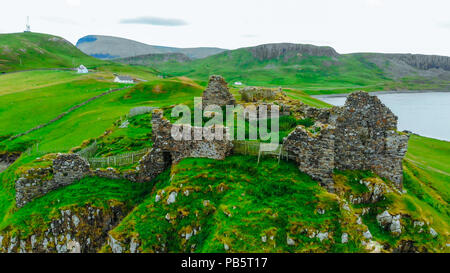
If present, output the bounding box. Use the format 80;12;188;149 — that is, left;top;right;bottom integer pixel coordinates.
15;154;90;208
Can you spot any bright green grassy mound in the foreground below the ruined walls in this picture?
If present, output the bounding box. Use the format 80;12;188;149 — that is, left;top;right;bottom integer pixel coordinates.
106;156;361;252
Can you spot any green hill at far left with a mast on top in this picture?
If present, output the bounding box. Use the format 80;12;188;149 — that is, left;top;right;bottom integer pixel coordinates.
0;32;100;73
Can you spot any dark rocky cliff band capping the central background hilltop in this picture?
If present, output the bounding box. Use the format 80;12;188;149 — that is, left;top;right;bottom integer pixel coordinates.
248;43;339;61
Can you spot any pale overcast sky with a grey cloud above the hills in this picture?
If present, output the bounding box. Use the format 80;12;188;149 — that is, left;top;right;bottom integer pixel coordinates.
0;0;450;56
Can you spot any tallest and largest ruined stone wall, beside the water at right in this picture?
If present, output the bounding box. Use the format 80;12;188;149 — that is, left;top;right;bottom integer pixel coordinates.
284;92;409;189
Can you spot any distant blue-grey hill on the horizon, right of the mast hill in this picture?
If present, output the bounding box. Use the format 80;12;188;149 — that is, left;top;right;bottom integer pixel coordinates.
77;35;229;59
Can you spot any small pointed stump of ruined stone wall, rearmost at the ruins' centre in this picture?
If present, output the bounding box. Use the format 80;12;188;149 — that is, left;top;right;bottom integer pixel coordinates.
203;75;236;109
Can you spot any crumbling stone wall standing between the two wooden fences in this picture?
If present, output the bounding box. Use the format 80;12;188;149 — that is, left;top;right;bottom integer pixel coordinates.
139;110;233;181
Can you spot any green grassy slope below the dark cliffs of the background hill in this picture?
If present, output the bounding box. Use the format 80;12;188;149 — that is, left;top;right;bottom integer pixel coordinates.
154;44;450;93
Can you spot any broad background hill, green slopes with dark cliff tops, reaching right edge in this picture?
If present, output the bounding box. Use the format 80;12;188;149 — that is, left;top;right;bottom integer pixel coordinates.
154;44;450;93
